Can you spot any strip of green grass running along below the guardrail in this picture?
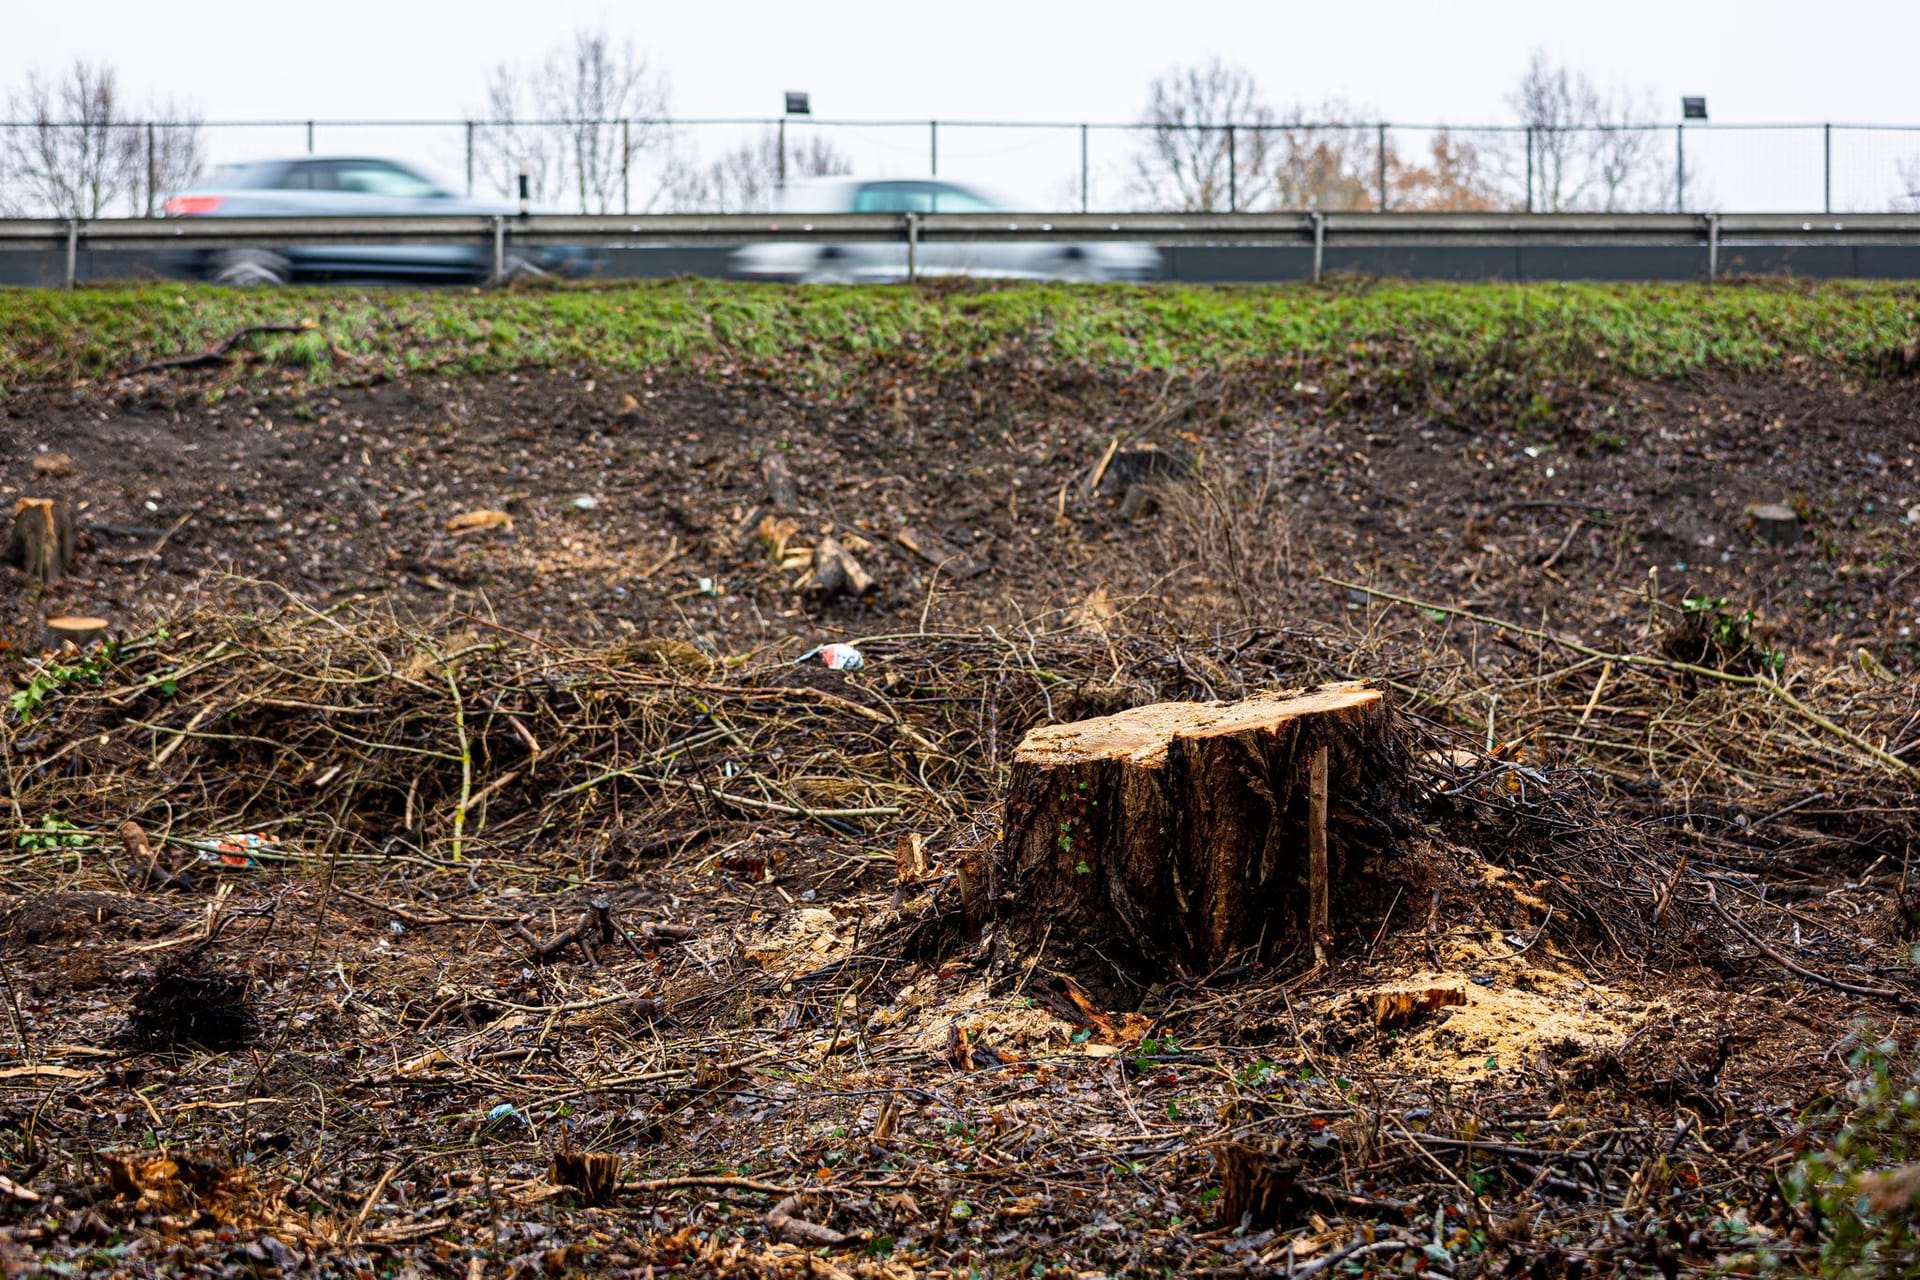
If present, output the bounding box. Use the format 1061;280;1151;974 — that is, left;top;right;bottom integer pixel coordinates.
0;280;1920;388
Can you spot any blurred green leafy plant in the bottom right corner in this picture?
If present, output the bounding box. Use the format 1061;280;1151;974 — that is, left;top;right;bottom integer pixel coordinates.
1784;1040;1920;1278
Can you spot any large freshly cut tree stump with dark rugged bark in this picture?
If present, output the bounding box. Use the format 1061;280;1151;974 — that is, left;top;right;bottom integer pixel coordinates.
993;683;1405;984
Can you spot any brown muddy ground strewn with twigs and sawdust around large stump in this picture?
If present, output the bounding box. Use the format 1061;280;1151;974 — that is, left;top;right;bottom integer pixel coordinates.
0;353;1920;1276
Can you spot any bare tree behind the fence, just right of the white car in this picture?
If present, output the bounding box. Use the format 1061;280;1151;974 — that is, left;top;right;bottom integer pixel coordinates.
1133;58;1275;213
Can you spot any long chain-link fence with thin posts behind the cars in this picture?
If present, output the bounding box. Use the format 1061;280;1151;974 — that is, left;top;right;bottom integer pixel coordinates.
0;115;1920;217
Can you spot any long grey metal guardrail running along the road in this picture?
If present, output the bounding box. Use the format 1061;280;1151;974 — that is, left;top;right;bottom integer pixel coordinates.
0;213;1920;288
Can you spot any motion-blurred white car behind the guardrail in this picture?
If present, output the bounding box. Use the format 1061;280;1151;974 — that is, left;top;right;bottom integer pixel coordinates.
732;178;1160;284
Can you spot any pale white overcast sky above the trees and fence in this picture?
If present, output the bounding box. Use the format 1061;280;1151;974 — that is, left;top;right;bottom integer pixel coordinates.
0;0;1920;207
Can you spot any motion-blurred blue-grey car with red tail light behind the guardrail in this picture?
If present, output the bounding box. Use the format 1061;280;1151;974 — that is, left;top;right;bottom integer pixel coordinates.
163;155;593;284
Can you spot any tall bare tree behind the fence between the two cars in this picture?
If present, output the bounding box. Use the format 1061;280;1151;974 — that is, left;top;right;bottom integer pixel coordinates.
474;29;670;213
